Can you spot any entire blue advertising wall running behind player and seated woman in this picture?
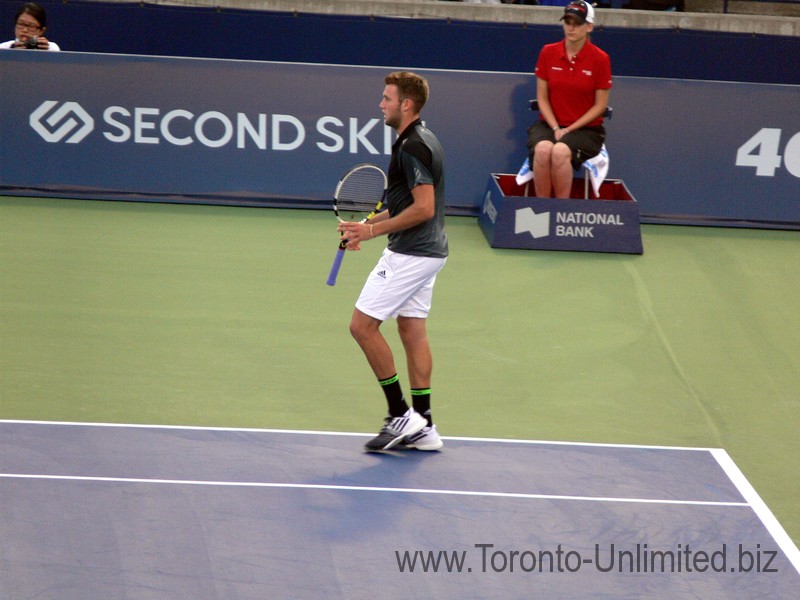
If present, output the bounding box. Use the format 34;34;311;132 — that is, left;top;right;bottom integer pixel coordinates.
0;52;800;229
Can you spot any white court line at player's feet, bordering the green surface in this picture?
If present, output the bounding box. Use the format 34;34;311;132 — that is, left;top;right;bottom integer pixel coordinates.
0;419;713;452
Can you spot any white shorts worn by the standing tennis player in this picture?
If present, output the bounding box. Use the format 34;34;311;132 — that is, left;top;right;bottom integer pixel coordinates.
356;248;447;321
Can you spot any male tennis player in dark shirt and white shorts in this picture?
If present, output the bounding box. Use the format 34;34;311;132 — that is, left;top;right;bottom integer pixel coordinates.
339;71;448;452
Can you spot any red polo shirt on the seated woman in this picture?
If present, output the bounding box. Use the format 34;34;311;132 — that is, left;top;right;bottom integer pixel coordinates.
536;40;611;127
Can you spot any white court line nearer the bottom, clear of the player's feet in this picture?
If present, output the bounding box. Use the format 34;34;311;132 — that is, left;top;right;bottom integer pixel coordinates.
0;473;749;508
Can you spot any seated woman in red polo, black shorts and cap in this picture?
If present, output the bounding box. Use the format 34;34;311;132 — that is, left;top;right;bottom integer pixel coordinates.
527;0;611;198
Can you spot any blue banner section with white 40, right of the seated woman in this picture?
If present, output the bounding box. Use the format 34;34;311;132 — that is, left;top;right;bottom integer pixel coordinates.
607;77;800;229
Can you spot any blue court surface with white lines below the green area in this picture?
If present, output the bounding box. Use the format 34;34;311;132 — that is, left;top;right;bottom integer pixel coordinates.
0;421;800;600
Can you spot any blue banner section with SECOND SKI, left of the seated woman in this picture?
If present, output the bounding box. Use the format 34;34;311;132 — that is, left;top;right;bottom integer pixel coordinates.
0;52;530;213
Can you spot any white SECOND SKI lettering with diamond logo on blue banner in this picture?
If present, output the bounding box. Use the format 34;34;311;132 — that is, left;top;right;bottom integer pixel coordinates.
29;100;394;155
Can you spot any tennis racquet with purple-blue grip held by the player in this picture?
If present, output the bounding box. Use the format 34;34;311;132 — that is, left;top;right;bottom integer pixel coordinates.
326;163;388;285
